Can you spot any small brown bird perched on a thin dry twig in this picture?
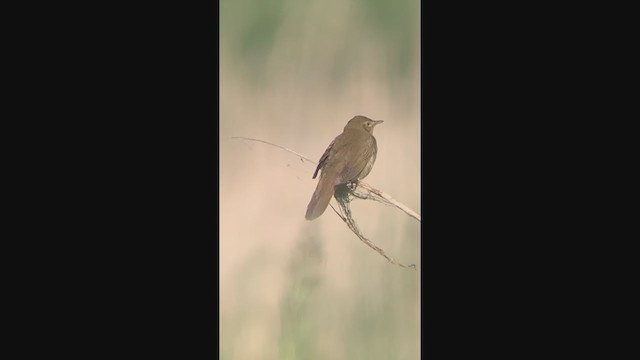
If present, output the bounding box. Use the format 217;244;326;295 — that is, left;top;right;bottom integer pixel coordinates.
305;116;383;220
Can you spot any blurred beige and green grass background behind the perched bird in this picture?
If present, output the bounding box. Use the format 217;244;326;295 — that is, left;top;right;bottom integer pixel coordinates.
219;0;420;359
